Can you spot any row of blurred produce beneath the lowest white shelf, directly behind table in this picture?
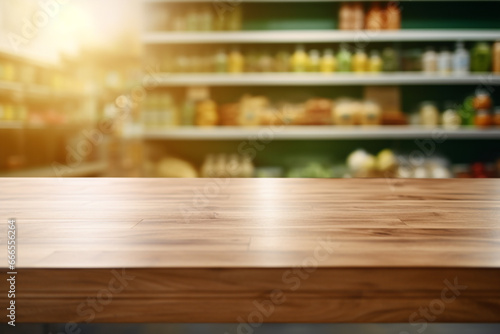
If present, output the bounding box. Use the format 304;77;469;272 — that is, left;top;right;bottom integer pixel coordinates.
148;149;500;178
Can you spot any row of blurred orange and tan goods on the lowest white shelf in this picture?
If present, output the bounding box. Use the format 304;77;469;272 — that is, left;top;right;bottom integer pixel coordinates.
142;87;500;129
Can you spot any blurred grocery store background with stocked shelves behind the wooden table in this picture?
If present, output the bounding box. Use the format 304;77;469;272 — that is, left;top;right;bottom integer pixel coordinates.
0;0;500;178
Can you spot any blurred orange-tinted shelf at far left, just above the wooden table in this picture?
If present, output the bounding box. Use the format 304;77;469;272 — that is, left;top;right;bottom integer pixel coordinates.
0;161;108;177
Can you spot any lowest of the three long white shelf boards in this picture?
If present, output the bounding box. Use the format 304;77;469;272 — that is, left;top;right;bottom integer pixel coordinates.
143;126;500;140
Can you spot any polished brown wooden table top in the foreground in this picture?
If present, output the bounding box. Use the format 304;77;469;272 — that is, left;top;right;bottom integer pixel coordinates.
0;178;500;322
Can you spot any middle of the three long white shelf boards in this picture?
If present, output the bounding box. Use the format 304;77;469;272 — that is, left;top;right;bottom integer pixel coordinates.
152;72;500;86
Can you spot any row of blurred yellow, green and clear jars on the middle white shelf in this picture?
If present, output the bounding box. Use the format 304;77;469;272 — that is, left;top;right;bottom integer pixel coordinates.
155;42;500;75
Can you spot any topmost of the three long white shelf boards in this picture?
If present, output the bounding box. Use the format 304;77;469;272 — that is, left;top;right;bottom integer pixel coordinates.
142;29;500;44
